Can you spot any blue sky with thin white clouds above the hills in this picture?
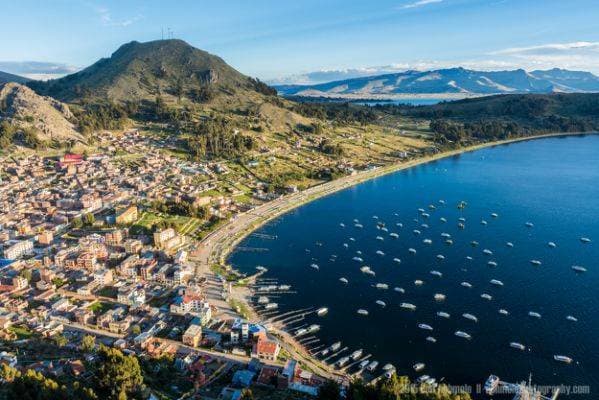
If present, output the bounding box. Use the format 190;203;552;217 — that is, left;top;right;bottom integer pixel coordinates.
0;0;599;81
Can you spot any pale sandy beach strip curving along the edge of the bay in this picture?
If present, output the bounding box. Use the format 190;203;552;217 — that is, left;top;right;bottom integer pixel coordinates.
197;132;598;378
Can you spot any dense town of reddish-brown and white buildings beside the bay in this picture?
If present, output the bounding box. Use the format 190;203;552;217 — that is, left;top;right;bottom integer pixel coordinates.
0;130;338;399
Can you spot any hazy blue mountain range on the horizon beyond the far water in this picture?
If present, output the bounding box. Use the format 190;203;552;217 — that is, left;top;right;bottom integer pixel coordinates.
275;68;599;98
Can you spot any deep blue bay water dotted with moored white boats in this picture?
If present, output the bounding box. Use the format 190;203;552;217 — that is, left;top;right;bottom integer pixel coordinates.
229;135;599;399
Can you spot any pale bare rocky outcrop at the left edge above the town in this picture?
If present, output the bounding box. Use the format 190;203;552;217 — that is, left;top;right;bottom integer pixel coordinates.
0;82;83;142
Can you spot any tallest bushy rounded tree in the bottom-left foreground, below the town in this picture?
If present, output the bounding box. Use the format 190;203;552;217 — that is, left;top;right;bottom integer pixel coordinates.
96;345;143;400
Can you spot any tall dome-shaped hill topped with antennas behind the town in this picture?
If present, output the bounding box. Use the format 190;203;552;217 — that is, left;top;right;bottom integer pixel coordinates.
29;39;272;102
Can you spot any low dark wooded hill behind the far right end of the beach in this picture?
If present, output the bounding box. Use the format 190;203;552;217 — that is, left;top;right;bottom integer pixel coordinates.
374;93;599;143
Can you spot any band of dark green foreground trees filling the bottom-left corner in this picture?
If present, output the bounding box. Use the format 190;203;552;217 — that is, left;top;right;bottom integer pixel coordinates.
0;345;145;400
